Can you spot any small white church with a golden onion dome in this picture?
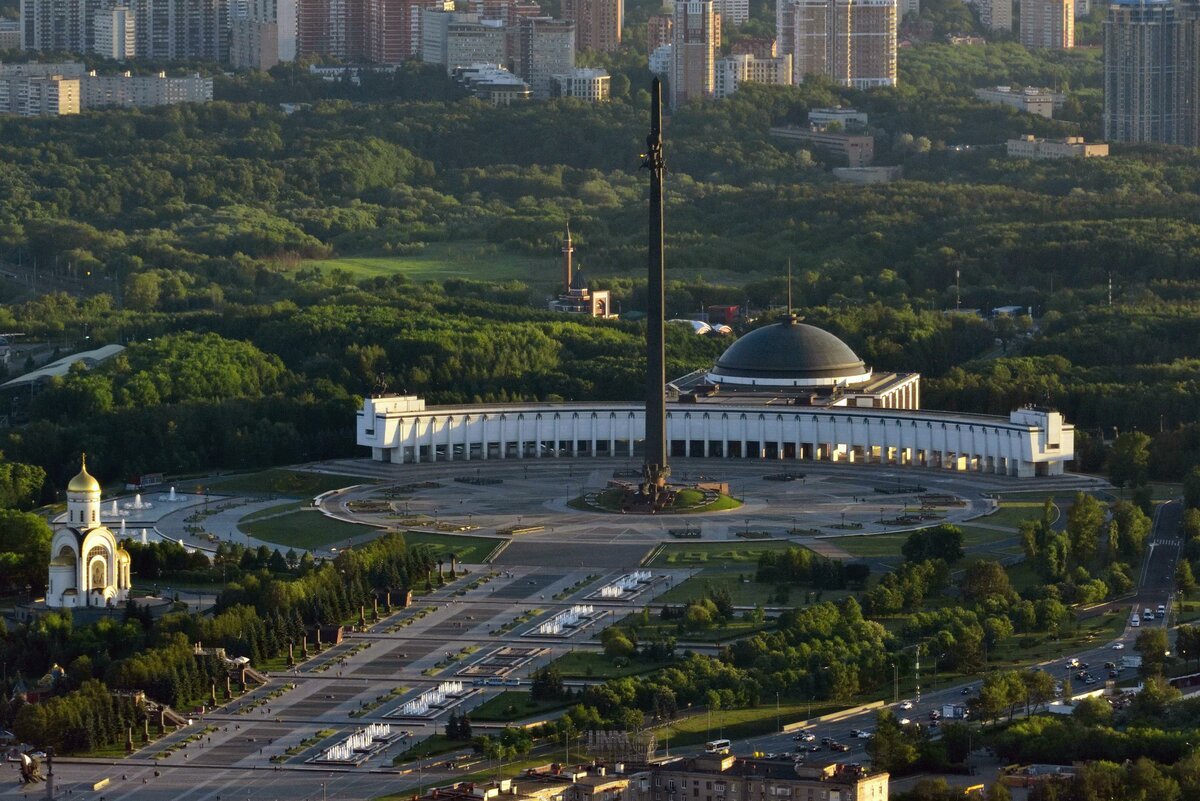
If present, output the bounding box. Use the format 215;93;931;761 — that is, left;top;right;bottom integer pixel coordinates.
46;457;130;609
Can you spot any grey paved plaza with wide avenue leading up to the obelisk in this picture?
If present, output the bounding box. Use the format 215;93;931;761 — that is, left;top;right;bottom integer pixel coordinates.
11;459;1104;801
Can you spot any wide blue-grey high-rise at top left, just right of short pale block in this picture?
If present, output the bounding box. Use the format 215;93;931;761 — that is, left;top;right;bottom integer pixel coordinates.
132;0;229;61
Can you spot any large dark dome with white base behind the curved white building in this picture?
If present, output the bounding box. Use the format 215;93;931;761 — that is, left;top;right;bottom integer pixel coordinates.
709;320;871;386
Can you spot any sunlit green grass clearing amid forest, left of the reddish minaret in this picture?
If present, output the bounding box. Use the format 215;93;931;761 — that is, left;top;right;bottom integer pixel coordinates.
300;240;558;285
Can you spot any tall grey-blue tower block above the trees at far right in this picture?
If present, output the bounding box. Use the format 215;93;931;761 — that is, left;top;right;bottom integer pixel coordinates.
1104;0;1180;144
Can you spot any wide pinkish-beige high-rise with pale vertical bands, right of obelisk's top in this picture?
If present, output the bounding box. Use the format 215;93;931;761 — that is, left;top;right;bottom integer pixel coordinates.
775;0;896;89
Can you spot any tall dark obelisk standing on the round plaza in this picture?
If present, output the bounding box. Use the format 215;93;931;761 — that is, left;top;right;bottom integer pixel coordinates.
642;78;671;505
